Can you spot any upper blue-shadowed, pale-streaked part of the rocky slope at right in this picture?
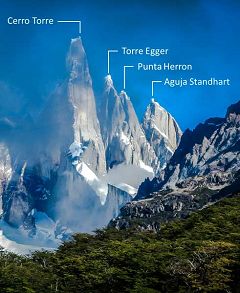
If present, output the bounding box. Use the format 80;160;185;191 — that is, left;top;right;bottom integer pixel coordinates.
164;103;240;187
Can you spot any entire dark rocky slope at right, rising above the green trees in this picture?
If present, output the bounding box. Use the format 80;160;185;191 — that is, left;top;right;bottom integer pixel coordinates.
110;102;240;230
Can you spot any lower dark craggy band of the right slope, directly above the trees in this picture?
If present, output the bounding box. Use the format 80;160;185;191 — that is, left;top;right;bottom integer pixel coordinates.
109;172;240;232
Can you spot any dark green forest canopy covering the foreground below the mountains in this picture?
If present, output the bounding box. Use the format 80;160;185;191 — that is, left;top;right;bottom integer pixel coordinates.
0;196;240;293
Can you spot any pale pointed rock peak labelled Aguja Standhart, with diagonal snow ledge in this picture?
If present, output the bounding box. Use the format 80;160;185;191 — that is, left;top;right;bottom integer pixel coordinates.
142;99;182;169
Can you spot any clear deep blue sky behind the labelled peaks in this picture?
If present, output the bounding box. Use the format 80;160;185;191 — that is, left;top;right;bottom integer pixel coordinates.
0;0;240;129
